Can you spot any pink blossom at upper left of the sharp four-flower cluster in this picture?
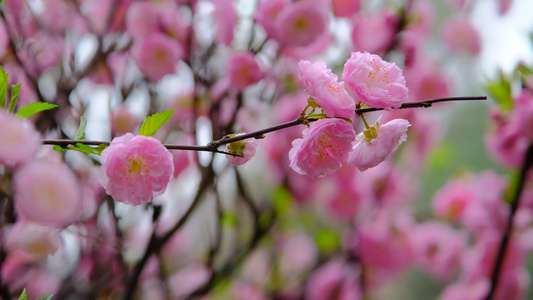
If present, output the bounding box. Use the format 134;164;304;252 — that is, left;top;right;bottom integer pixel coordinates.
298;60;355;119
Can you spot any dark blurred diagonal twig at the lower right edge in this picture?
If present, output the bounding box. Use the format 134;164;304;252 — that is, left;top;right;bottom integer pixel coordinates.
485;144;533;300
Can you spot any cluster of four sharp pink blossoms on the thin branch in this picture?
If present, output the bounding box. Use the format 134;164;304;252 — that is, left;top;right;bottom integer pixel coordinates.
289;52;410;178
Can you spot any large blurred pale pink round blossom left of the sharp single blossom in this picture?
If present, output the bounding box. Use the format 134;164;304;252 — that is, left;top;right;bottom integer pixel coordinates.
13;161;81;227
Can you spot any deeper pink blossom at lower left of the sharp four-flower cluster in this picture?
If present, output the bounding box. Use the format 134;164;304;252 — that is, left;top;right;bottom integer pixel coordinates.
289;119;355;178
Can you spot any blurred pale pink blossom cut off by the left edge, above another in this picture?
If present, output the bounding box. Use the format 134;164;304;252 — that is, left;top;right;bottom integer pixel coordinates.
0;109;41;166
